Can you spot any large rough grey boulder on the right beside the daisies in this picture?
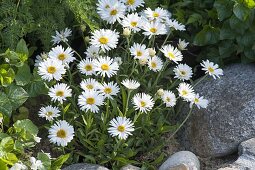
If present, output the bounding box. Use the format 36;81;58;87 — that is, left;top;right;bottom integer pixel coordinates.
180;64;255;157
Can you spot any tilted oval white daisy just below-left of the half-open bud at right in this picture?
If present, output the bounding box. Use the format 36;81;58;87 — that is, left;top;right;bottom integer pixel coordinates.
160;44;183;63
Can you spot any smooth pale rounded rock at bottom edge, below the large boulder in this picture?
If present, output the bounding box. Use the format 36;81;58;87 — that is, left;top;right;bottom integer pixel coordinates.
159;151;200;170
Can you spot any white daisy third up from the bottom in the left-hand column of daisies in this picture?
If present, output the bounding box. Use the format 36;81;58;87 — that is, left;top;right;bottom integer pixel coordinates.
48;83;72;104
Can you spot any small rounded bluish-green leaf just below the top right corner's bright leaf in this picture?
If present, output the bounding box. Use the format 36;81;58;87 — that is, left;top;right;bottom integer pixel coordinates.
233;3;251;21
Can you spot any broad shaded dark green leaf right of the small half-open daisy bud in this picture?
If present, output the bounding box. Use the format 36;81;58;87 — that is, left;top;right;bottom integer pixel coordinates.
194;25;220;46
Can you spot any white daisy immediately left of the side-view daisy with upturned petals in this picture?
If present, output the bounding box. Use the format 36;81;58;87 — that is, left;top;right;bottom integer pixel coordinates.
99;82;120;99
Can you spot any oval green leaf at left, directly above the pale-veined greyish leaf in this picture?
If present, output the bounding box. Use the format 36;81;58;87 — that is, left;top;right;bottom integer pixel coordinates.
15;64;32;86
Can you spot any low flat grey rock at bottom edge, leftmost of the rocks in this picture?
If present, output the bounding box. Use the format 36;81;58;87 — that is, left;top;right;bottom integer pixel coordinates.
63;163;109;170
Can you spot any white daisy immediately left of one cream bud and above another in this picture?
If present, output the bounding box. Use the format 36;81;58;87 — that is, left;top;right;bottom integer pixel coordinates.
130;43;149;60
